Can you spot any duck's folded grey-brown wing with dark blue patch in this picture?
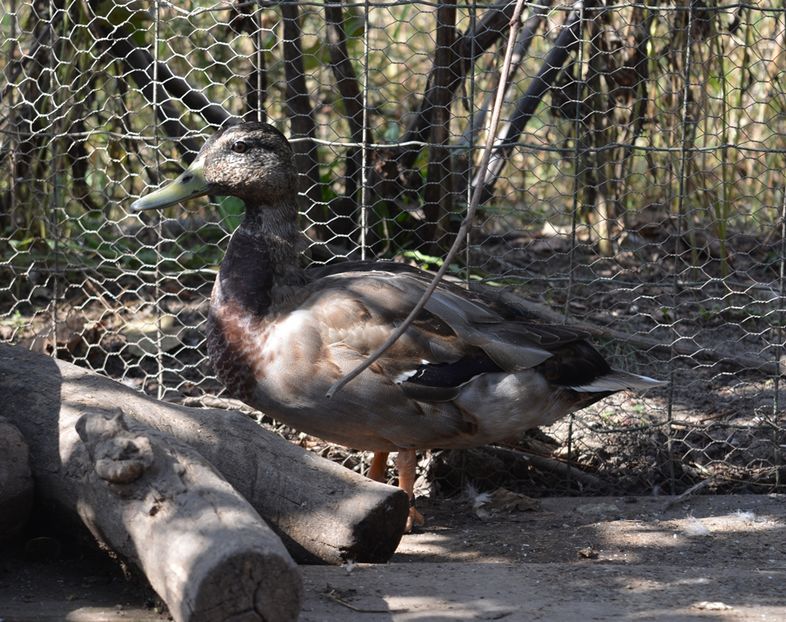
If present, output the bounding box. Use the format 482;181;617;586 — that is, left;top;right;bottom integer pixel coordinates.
306;262;609;402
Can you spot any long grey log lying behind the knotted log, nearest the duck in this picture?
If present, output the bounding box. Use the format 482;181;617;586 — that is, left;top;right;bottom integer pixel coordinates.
0;345;409;563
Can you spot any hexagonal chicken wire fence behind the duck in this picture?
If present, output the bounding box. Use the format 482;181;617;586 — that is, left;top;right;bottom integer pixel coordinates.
0;0;786;494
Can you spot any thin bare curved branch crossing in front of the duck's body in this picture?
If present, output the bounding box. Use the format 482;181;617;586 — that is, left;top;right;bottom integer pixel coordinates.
326;0;524;397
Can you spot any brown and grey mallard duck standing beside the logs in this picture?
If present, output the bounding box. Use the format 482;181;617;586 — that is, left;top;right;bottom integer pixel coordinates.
132;123;661;530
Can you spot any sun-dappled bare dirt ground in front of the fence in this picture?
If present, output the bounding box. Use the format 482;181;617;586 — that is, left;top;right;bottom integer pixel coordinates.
0;495;786;622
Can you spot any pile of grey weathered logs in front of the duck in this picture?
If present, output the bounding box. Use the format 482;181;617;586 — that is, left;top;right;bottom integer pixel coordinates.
0;345;408;621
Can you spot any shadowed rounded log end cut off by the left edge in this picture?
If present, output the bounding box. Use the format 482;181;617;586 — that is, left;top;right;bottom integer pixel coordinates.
0;417;33;542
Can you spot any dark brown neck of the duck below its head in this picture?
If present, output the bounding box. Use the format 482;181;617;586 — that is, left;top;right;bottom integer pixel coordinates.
213;202;302;315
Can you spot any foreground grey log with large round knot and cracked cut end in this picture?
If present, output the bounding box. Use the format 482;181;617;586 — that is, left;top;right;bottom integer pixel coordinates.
72;410;303;622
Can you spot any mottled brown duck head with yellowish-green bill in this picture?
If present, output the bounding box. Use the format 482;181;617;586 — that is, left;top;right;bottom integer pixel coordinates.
131;122;297;212
